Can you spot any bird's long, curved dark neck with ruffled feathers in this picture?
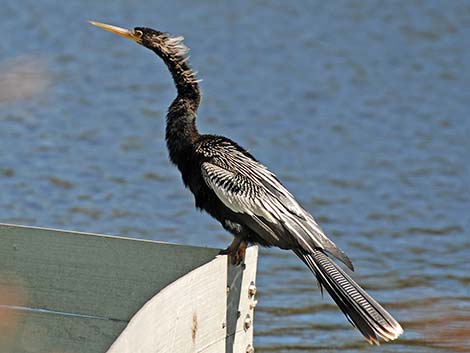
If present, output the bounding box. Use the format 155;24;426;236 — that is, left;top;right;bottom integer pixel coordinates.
152;40;201;169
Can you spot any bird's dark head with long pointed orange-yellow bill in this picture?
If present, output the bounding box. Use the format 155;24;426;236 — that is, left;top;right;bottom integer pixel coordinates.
90;21;189;61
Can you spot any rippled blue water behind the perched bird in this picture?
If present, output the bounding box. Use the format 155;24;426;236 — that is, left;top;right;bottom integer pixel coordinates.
0;0;470;353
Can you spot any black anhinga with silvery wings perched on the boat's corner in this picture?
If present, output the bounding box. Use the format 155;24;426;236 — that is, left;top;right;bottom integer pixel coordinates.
90;21;403;345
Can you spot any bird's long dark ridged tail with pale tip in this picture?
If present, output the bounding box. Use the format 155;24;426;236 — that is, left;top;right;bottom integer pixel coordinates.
296;250;403;345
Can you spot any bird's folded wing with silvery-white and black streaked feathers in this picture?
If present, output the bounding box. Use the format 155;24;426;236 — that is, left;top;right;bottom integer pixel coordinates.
201;150;352;269
